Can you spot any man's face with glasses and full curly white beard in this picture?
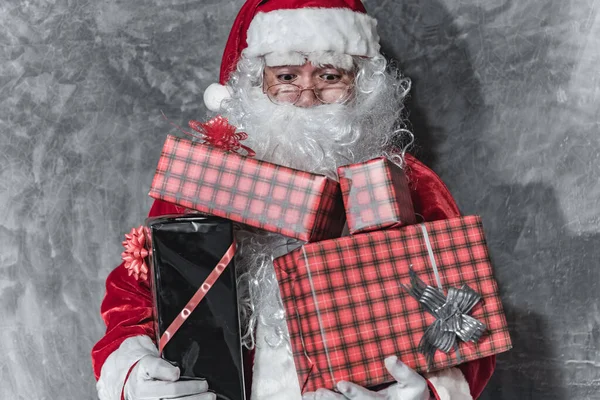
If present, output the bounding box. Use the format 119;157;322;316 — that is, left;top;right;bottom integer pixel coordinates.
224;59;397;179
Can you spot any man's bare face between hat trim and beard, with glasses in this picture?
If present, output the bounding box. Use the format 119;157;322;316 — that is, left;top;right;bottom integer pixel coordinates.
263;62;354;108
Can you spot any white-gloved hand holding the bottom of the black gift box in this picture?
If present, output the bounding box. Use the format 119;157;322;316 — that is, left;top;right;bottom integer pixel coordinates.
125;355;217;400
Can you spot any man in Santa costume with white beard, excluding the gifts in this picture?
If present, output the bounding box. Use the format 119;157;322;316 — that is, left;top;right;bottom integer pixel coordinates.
92;0;495;400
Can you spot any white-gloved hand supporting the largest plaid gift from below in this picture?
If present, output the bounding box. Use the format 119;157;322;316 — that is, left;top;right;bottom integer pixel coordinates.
302;356;430;400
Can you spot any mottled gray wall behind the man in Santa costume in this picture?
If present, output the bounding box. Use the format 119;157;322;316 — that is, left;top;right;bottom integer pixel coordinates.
0;0;600;400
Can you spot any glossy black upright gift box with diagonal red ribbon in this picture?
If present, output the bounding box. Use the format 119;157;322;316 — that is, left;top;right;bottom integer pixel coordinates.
147;215;245;400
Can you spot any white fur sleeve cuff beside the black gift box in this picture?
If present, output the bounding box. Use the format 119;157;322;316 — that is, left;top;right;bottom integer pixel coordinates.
96;335;158;400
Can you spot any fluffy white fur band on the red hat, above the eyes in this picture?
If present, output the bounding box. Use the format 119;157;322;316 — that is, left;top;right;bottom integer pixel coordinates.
242;8;380;58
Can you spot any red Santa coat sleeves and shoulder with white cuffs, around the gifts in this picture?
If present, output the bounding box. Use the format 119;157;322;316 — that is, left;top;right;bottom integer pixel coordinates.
92;155;496;400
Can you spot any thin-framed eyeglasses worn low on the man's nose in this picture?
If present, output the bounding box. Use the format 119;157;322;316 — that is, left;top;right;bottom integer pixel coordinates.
265;82;354;105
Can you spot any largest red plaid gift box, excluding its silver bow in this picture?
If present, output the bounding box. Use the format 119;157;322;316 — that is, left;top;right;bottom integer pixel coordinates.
275;216;512;392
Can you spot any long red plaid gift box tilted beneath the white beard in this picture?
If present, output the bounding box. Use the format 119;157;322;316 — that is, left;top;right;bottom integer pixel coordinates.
149;135;344;242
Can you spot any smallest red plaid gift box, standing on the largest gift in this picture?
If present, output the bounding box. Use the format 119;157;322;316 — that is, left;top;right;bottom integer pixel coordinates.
338;157;416;234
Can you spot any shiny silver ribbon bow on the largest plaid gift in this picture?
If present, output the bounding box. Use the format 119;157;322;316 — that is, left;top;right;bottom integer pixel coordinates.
402;268;486;366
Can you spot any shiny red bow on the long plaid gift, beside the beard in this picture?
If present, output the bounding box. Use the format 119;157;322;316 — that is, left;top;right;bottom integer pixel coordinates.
189;115;256;157
